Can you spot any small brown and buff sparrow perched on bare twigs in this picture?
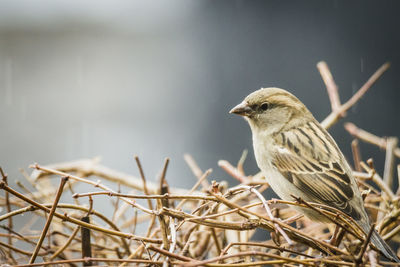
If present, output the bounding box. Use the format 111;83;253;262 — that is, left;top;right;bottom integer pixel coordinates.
230;87;400;262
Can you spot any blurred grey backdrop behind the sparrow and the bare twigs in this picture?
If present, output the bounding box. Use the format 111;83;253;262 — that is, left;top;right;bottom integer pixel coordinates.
0;0;400;194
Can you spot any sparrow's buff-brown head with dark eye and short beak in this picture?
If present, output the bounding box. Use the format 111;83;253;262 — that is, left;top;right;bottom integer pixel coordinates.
229;87;313;133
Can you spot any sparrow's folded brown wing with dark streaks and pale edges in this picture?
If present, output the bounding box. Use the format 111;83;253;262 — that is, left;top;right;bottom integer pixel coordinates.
272;122;361;220
